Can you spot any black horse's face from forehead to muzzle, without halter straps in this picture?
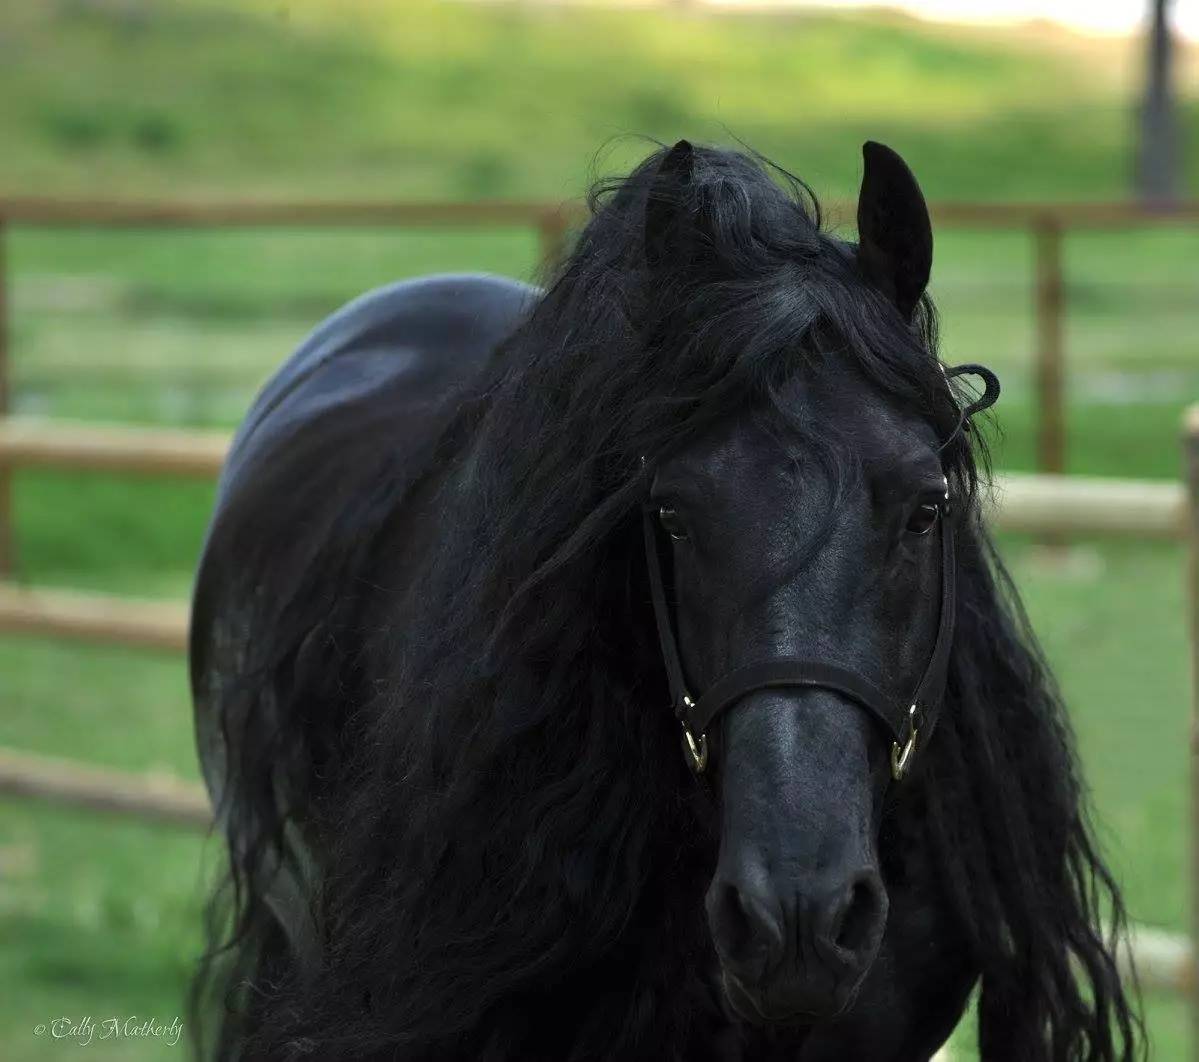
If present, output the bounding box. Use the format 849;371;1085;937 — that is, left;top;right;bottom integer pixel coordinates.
652;367;945;1022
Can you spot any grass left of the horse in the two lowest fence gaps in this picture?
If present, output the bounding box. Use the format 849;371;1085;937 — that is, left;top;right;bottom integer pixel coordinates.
0;639;207;1062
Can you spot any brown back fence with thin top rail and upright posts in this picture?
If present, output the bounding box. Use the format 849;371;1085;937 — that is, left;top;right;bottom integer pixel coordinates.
0;197;1199;575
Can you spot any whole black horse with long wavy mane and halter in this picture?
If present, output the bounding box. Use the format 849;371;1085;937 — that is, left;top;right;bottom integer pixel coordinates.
192;141;1143;1062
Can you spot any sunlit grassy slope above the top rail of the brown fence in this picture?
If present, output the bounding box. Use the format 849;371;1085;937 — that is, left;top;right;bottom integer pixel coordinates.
0;0;1199;199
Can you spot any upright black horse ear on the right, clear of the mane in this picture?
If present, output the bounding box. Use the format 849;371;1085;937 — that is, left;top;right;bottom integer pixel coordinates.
857;140;933;319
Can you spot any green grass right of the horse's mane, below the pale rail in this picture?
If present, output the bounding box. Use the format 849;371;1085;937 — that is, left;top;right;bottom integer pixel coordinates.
954;539;1189;1062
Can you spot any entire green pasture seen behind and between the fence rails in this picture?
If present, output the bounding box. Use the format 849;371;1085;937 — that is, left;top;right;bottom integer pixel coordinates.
0;0;1199;1062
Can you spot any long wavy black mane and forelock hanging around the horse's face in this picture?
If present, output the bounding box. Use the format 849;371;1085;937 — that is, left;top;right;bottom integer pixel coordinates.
198;149;1139;1062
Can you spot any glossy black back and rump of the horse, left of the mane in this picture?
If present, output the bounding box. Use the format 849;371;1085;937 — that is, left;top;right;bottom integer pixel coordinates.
191;276;537;813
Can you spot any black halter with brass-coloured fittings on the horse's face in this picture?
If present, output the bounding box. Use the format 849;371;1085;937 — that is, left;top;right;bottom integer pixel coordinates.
641;364;999;782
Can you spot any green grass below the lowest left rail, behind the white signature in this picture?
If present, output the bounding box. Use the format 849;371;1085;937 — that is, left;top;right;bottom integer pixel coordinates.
0;807;204;1062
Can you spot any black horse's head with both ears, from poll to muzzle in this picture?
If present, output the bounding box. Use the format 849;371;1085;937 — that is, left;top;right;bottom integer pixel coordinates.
645;141;973;1022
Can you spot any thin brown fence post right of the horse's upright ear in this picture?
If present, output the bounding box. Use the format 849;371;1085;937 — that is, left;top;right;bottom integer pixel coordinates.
1035;213;1066;473
